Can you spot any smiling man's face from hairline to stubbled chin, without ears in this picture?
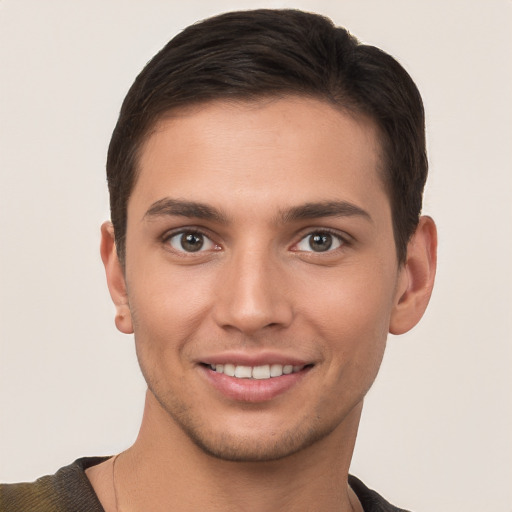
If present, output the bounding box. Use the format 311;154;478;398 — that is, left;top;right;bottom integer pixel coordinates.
115;97;404;460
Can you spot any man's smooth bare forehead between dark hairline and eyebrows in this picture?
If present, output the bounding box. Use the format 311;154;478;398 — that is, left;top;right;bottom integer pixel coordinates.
129;96;384;219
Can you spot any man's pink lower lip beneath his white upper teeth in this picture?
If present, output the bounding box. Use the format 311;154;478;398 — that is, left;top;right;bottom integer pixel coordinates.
201;366;311;402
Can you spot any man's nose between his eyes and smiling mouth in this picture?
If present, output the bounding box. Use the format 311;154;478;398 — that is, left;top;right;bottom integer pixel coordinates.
213;248;293;335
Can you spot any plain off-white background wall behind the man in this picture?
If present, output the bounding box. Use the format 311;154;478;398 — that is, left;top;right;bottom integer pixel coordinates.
0;0;512;512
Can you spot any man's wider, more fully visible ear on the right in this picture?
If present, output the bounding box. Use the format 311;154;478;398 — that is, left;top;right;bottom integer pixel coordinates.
389;216;437;334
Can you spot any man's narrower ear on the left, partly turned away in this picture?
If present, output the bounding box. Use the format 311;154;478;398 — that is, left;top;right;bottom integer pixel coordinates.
100;222;133;334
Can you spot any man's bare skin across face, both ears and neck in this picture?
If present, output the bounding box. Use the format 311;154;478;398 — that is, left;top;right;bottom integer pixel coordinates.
88;97;436;511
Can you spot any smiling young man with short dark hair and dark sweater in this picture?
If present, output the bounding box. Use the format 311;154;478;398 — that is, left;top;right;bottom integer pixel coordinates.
0;10;436;512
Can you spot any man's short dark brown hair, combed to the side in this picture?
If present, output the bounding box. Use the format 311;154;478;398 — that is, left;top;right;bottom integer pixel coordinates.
107;9;428;263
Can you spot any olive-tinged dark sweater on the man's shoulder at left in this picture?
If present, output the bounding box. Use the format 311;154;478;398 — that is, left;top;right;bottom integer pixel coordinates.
0;457;105;512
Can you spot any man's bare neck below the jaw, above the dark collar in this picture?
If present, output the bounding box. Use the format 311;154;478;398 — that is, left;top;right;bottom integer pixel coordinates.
115;393;362;512
